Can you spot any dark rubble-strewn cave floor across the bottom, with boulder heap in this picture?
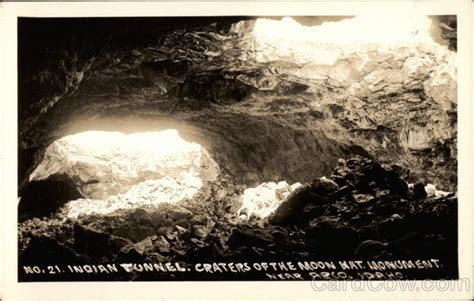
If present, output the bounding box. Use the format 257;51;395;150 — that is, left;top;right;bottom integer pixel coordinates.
18;157;457;281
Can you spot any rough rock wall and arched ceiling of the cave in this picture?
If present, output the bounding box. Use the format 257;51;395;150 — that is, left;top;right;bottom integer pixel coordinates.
19;18;457;197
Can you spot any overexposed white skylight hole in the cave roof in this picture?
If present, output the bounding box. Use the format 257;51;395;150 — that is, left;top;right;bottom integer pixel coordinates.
253;14;434;65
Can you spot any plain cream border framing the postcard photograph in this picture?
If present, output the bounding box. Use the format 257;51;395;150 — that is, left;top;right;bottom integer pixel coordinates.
0;0;474;300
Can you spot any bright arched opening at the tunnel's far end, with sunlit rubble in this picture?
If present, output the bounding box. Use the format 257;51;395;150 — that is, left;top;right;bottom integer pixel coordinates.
30;130;219;218
